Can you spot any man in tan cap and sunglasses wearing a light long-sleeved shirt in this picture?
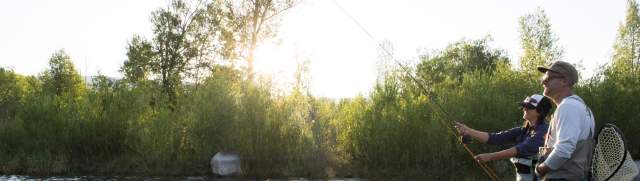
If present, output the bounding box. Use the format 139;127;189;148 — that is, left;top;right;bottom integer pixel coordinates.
535;61;595;180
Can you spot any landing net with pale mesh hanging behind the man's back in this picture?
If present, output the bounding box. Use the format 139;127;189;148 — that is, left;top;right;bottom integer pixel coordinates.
591;126;638;180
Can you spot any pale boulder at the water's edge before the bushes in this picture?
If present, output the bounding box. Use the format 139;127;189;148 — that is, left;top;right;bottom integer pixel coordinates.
211;152;242;176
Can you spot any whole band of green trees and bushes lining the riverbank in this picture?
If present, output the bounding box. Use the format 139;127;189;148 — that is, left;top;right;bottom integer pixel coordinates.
0;1;640;180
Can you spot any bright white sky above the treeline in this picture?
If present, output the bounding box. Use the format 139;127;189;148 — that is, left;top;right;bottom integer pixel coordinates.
0;0;627;98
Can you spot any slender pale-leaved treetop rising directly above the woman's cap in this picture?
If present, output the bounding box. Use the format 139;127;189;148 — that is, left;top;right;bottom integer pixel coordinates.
520;8;564;72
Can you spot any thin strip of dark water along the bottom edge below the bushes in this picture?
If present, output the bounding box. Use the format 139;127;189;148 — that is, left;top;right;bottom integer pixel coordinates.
0;175;364;181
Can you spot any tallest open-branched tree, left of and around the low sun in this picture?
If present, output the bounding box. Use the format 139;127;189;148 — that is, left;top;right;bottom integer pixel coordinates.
121;0;229;106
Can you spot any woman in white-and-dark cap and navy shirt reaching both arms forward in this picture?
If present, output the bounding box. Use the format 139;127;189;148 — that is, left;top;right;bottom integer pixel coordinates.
456;94;551;181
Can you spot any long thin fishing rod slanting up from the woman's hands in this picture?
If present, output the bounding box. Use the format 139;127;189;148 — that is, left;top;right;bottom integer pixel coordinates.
333;0;500;181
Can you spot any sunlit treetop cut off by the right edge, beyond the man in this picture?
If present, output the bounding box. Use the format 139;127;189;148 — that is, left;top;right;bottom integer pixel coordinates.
609;0;640;74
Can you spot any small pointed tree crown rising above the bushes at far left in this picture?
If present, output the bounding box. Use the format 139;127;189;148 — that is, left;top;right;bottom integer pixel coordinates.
42;50;85;100
